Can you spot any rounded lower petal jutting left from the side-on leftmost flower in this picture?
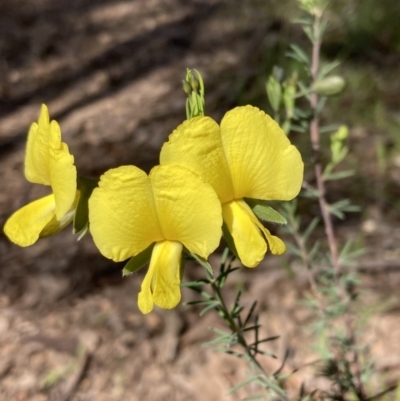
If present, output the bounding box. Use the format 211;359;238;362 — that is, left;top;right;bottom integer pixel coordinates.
4;195;56;246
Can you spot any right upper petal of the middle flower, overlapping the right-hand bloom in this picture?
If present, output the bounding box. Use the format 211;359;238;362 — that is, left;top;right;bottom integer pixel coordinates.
150;164;222;258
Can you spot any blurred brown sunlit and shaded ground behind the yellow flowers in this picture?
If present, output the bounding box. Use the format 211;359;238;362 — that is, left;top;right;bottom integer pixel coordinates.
0;0;400;401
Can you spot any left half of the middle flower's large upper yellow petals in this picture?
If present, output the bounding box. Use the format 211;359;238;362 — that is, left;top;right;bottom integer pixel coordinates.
89;166;164;262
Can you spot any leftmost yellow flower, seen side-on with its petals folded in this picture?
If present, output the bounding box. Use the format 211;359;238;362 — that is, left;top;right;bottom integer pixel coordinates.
4;105;79;246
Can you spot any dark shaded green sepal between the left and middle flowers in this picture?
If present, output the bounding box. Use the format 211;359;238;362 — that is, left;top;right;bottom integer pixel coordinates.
73;177;98;240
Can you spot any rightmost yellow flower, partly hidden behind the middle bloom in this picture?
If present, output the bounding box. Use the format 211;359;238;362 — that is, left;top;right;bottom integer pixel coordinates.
160;106;303;267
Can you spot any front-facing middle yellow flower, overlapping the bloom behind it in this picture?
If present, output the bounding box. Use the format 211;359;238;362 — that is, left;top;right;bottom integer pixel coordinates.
89;165;222;313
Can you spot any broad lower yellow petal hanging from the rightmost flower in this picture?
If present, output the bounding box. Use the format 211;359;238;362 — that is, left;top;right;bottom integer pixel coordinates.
222;200;268;267
